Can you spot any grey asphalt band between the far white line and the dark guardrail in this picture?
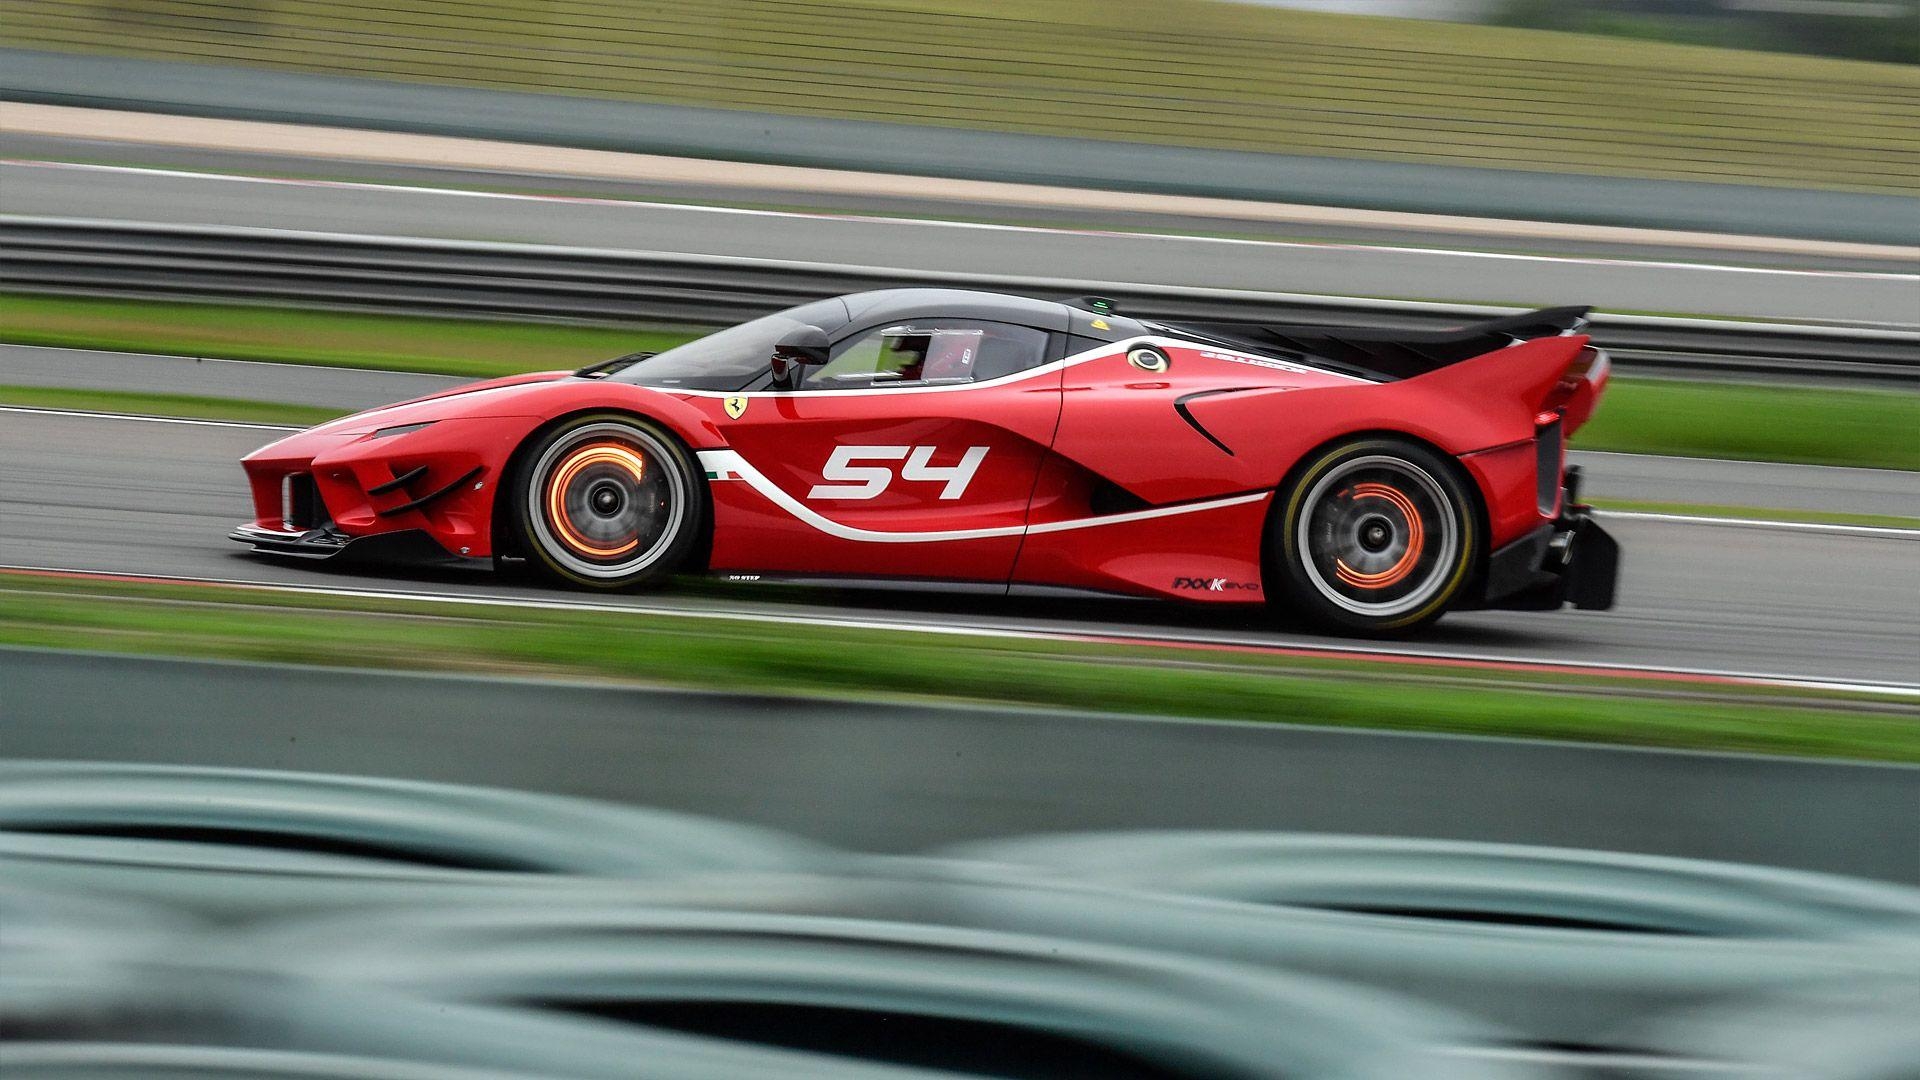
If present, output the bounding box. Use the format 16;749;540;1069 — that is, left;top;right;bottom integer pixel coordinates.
0;161;1920;325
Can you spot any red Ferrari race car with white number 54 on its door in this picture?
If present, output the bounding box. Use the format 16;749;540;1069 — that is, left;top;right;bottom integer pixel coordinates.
232;288;1619;634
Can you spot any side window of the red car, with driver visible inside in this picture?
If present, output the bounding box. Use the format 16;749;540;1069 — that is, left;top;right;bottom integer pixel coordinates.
804;319;1046;390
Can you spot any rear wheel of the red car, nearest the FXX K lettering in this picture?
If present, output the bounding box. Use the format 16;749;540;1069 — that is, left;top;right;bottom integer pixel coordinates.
1269;438;1480;636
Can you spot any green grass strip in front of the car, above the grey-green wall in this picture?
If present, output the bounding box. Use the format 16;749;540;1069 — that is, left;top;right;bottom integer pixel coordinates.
0;575;1920;761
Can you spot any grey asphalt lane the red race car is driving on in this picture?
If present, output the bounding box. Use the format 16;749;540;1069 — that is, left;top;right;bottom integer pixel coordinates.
0;403;1920;686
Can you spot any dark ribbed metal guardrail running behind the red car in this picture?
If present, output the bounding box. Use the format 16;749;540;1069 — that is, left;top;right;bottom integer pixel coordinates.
0;215;1920;384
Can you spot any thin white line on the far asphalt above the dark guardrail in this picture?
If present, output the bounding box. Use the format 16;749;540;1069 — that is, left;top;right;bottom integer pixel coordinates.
15;160;1920;281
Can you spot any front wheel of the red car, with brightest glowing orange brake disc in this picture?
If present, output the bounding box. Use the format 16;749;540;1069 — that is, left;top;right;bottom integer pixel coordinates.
503;413;707;590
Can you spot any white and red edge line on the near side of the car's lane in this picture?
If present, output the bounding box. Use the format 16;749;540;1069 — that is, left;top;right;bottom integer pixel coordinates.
0;563;1920;700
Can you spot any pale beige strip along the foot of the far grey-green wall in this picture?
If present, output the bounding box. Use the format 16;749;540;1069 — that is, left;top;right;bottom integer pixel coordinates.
0;127;1914;273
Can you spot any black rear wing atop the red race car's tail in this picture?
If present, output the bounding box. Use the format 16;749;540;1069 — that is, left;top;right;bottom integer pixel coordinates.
1175;307;1592;382
